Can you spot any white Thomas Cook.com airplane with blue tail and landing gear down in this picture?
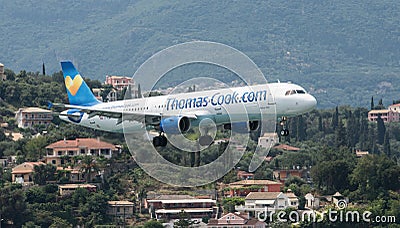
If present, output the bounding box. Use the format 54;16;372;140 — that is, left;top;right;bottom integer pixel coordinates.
50;61;317;147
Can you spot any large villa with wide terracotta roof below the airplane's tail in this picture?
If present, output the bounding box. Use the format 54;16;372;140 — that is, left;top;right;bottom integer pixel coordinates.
44;138;118;166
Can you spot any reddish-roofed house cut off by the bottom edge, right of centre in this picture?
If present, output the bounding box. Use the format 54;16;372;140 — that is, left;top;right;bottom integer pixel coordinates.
207;213;266;228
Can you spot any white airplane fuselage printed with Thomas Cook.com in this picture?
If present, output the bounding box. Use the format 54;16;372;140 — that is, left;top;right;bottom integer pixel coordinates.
60;83;317;133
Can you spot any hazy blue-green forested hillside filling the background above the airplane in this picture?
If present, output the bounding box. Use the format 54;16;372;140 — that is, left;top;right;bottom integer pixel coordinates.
0;0;400;108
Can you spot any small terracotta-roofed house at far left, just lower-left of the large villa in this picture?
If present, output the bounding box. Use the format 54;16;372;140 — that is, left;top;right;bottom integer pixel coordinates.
11;162;45;184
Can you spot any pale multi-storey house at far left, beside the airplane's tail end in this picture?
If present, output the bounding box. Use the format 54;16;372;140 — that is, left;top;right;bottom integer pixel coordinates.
15;107;53;128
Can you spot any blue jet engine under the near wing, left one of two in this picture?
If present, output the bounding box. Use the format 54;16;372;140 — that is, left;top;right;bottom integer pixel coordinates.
160;116;190;134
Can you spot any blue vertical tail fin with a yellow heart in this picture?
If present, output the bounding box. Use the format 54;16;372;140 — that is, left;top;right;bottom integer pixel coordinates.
61;61;100;106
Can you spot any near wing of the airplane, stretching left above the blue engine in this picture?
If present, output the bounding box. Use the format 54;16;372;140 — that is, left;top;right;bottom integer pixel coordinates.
49;104;197;125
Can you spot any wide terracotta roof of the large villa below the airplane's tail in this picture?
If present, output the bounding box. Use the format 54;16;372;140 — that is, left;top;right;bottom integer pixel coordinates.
46;138;116;150
